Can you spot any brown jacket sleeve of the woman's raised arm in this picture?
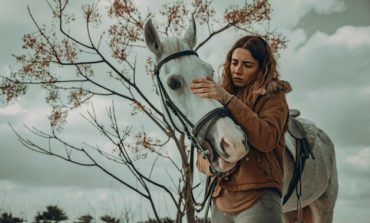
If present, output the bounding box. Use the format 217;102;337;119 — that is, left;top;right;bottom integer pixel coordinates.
227;92;289;152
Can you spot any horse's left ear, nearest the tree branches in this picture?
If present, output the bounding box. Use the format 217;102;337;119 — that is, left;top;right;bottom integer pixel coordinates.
144;19;163;57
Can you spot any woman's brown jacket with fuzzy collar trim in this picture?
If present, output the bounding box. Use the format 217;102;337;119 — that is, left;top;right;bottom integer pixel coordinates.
197;80;291;197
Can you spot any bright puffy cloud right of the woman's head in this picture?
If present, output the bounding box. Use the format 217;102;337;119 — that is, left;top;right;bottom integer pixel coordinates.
283;26;370;92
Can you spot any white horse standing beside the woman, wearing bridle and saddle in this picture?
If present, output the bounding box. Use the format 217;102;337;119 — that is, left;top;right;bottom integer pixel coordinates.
144;20;338;223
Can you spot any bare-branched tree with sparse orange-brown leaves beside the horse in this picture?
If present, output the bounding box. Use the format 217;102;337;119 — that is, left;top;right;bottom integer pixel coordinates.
0;0;285;222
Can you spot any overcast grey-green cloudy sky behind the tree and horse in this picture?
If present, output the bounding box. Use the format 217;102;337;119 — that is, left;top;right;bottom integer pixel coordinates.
0;0;370;223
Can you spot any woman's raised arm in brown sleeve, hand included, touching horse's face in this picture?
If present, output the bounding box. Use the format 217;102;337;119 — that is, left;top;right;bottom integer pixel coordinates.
190;78;289;152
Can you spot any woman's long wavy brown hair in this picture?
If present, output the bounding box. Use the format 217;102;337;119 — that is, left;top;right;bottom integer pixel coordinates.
222;35;279;106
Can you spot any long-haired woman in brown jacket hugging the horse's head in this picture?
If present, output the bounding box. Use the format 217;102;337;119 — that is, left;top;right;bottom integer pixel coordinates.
191;36;291;223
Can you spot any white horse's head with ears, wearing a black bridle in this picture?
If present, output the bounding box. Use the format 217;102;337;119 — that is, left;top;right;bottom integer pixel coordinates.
144;17;248;167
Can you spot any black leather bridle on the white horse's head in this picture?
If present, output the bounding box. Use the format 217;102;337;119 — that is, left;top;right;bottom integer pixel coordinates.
154;50;230;211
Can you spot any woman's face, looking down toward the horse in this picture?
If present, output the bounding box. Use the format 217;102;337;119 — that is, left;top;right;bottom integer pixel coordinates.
230;48;258;88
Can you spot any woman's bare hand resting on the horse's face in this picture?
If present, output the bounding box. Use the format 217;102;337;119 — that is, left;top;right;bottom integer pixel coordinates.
190;76;233;105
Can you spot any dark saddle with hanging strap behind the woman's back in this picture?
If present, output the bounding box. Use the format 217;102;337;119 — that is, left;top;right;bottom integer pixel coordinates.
283;109;315;204
